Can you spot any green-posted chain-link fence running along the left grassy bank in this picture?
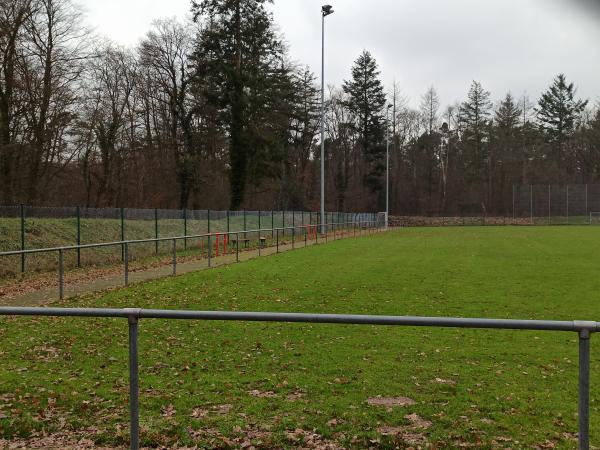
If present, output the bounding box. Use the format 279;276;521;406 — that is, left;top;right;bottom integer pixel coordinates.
0;205;378;276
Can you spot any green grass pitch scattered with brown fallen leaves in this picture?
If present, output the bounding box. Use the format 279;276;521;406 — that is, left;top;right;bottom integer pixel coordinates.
0;227;600;449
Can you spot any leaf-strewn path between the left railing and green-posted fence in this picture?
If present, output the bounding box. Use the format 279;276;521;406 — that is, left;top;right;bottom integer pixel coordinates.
0;231;384;306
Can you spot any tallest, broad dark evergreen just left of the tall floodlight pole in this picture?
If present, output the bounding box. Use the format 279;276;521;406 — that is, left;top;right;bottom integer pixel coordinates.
192;0;291;209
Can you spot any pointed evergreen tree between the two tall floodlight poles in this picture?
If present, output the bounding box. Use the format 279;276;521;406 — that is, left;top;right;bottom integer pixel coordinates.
343;51;386;193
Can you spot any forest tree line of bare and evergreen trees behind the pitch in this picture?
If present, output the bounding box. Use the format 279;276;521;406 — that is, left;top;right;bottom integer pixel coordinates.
0;0;600;214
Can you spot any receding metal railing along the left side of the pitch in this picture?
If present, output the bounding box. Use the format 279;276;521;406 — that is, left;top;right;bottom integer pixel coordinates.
0;221;384;300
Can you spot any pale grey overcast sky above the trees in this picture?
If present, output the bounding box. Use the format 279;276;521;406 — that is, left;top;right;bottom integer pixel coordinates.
79;0;600;106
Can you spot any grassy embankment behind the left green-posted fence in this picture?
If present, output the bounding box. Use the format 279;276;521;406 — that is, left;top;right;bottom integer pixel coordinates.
0;214;309;282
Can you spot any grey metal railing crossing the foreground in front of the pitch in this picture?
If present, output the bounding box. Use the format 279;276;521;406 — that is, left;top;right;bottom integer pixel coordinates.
0;307;600;450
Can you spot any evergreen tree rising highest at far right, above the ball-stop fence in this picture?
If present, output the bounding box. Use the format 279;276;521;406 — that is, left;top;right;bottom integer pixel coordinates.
536;73;588;158
